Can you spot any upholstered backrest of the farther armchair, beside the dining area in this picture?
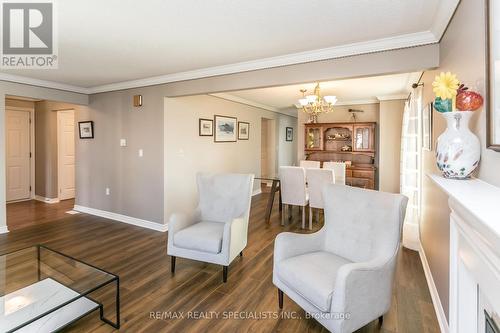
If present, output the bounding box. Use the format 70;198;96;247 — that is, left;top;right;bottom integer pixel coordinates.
197;173;253;222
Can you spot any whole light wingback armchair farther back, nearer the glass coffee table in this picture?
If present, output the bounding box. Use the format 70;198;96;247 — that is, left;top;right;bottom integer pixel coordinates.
167;174;254;282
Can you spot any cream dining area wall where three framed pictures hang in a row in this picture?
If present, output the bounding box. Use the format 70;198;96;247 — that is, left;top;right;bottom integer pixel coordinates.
164;95;296;221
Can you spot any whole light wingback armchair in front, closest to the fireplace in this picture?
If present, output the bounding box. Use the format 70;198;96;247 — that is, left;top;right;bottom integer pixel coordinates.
273;185;408;333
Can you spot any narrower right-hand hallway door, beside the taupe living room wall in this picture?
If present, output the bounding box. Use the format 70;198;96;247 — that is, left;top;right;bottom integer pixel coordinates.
57;110;75;200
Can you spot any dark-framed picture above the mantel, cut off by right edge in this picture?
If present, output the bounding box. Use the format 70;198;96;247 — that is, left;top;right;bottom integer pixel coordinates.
485;0;500;151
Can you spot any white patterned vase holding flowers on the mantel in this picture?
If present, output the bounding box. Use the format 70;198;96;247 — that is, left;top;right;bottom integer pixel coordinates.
436;111;481;179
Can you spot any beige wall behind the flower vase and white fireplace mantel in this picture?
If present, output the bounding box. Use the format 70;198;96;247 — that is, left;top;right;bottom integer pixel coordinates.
420;0;500;315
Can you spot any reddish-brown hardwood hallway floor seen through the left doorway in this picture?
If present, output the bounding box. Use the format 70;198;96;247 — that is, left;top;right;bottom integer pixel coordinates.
7;199;75;230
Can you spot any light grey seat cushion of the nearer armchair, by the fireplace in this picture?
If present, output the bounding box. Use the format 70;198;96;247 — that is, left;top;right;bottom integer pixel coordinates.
277;251;351;312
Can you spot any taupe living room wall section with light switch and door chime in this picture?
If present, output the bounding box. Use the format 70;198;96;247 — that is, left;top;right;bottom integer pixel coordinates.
76;86;165;223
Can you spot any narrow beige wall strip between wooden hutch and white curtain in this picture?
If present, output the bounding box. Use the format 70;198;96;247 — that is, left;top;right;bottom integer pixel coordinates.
379;100;405;193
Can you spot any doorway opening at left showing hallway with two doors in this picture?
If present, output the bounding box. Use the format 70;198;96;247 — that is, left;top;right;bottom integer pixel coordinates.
5;96;77;230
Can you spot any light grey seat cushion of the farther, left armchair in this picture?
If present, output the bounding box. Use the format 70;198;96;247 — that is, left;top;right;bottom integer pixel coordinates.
174;221;224;254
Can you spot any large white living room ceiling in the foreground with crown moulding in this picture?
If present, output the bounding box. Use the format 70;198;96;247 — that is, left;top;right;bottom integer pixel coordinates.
0;0;458;92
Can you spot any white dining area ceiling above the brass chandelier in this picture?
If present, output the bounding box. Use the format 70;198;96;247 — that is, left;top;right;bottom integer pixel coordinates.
223;72;421;113
